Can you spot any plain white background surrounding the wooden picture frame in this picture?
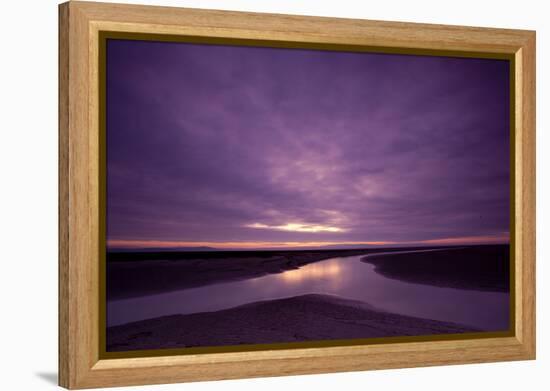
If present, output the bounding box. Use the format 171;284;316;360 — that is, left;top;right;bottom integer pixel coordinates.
0;0;550;391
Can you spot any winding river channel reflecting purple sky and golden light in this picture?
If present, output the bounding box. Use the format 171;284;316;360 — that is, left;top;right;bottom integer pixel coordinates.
107;256;509;331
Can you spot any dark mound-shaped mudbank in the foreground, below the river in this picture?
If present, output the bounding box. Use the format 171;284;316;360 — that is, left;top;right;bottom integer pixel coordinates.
107;294;478;351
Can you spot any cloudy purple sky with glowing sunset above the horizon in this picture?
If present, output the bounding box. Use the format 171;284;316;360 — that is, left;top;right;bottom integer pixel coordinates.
107;40;510;247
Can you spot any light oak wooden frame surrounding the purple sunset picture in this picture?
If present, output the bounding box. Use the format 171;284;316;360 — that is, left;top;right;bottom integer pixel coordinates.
59;1;535;389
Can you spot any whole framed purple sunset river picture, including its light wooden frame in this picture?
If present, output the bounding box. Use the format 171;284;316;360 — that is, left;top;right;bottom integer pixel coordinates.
59;2;535;388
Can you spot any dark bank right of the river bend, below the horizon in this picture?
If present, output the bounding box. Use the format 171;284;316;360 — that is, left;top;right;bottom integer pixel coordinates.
362;244;510;292
